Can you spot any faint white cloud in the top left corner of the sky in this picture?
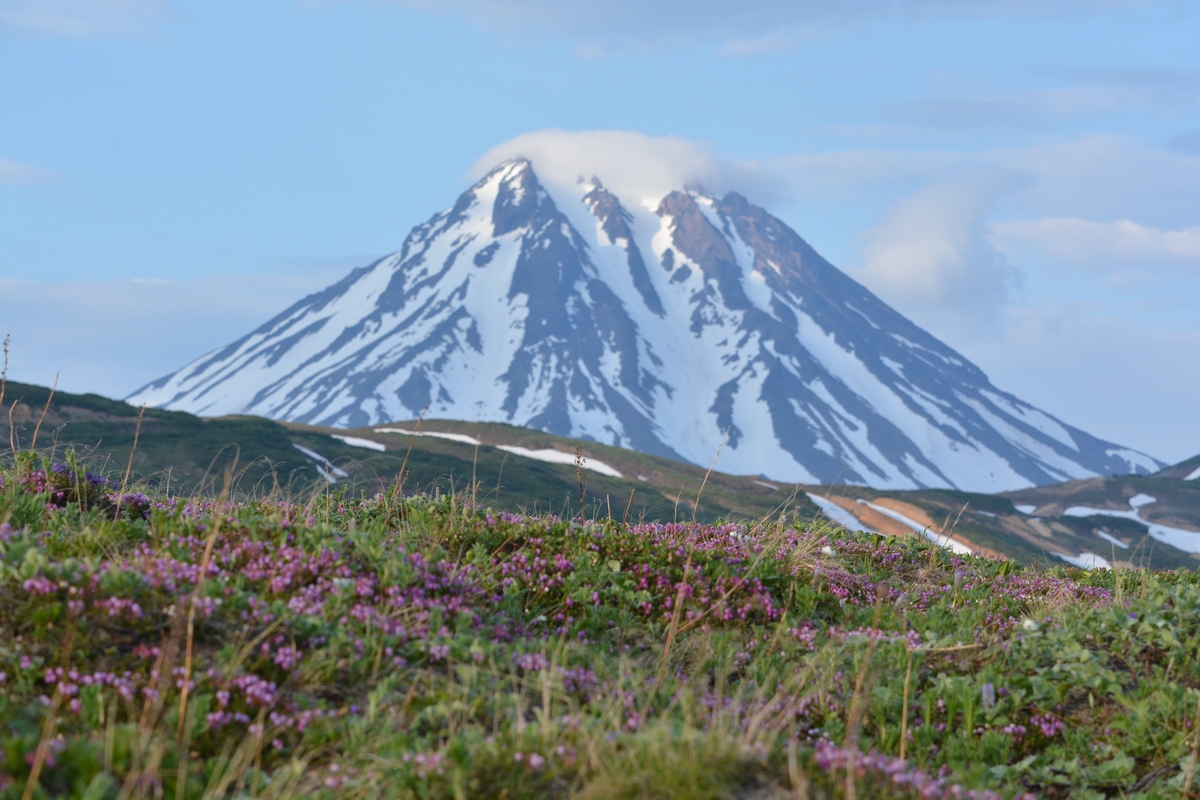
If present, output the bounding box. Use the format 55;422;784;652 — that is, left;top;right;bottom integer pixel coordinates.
0;0;179;38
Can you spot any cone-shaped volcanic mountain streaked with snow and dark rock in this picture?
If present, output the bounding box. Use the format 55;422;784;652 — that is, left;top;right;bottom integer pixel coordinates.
130;158;1163;492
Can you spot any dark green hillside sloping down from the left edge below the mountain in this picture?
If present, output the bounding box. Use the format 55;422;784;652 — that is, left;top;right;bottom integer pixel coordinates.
0;383;818;522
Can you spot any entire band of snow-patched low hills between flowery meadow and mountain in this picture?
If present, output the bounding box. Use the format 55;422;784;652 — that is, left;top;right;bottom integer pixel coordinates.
0;383;1200;569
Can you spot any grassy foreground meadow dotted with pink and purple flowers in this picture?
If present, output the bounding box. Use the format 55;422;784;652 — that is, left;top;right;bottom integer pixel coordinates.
0;453;1200;800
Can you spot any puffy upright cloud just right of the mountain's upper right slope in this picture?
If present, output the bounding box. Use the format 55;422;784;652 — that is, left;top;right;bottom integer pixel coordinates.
854;170;1020;338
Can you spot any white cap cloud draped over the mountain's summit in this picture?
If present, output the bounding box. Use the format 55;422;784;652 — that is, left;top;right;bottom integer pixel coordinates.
472;130;784;204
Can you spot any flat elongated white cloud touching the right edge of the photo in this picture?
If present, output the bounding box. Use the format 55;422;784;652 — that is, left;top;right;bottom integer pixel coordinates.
991;217;1200;267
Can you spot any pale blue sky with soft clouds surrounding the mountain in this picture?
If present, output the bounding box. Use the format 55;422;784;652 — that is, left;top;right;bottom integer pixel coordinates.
0;0;1200;461
